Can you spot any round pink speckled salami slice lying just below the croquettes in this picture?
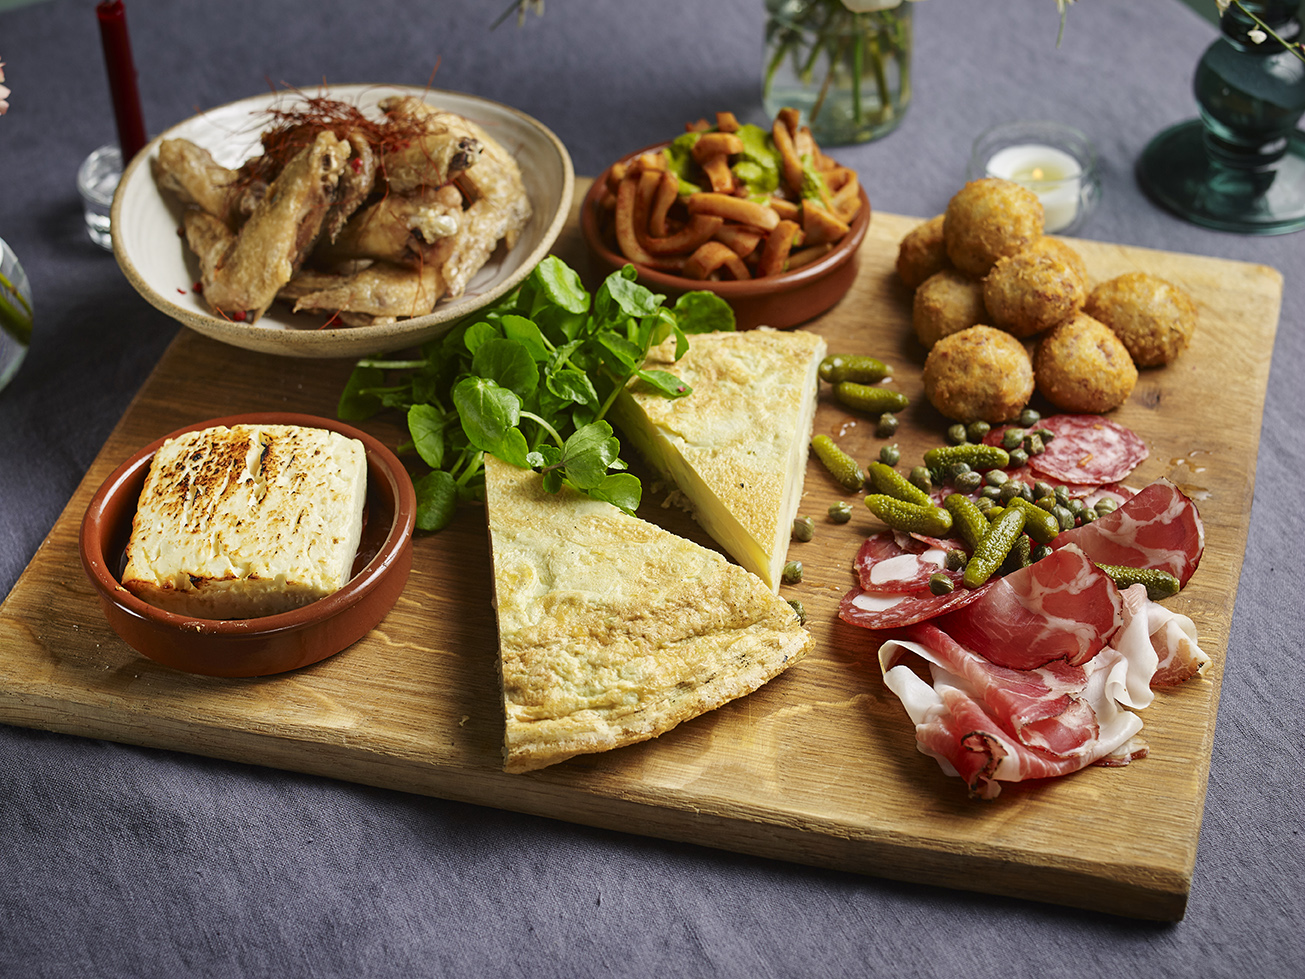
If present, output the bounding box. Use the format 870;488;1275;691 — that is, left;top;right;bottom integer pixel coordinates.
984;415;1148;486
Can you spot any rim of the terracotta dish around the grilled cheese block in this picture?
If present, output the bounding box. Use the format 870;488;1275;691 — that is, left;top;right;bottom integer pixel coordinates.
78;412;416;639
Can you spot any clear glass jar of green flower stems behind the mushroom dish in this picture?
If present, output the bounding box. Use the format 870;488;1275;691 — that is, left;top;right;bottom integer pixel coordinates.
762;0;911;146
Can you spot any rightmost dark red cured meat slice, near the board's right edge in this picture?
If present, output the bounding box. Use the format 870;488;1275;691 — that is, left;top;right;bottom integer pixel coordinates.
1051;479;1206;585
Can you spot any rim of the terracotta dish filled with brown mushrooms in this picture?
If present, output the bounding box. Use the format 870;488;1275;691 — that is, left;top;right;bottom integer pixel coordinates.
579;142;870;300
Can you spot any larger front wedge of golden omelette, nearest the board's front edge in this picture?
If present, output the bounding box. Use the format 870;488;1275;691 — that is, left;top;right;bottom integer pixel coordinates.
485;456;812;773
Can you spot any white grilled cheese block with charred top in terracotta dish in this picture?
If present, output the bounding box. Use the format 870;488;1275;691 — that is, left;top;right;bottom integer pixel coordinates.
123;426;367;619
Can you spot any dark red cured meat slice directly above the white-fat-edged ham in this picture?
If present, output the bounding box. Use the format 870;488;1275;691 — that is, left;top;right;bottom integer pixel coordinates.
938;538;1124;670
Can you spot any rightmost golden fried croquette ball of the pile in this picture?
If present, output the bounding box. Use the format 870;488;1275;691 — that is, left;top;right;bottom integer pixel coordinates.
1086;272;1197;367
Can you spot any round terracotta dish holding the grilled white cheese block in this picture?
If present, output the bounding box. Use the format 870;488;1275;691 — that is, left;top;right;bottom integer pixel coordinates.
80;412;416;676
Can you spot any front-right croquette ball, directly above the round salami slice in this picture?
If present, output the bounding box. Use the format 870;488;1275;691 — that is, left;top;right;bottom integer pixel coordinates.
1034;313;1138;414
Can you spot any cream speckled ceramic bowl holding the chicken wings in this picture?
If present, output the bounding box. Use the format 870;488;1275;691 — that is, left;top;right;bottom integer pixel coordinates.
110;85;576;358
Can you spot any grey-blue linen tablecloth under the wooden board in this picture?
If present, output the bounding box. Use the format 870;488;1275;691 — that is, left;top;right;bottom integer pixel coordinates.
0;0;1305;978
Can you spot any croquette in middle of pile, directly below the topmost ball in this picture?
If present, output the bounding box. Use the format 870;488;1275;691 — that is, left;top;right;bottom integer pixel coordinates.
983;238;1087;337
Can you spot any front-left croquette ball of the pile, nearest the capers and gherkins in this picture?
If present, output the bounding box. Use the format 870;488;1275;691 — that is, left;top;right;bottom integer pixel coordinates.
924;326;1034;424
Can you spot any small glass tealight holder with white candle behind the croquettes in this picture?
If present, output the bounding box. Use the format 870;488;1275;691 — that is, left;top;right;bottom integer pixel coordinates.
966;121;1101;235
